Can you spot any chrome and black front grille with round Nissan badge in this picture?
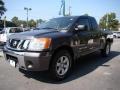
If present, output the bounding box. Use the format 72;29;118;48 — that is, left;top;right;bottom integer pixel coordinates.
6;39;30;50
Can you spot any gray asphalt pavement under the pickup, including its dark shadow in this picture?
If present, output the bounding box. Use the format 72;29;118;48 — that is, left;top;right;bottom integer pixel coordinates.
0;39;120;90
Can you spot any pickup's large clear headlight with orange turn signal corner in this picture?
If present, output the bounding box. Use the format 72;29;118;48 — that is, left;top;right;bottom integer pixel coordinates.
28;38;51;51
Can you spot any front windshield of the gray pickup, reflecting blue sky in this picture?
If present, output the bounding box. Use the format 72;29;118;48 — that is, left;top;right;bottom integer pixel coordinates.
39;17;76;30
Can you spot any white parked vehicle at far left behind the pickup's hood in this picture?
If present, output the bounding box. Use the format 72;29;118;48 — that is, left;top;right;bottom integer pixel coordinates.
0;27;23;44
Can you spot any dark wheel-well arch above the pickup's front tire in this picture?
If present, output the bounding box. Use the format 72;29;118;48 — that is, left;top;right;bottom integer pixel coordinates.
49;46;74;67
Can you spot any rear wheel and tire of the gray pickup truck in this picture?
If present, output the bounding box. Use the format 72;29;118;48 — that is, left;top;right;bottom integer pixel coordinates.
101;42;111;57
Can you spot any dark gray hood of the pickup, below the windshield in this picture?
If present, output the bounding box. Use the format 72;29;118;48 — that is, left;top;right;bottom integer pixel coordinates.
9;29;68;39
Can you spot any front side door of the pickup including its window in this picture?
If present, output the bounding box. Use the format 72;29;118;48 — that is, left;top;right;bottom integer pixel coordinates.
77;18;93;55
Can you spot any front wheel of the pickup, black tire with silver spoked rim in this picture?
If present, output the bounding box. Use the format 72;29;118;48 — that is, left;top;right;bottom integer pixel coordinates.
50;50;72;81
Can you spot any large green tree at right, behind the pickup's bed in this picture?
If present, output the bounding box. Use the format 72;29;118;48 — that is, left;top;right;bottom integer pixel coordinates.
99;13;119;30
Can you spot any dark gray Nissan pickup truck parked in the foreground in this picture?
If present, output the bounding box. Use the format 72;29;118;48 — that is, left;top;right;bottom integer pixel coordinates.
3;16;112;80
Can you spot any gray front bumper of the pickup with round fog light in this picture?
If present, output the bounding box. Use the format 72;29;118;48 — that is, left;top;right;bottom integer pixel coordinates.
3;47;51;71
